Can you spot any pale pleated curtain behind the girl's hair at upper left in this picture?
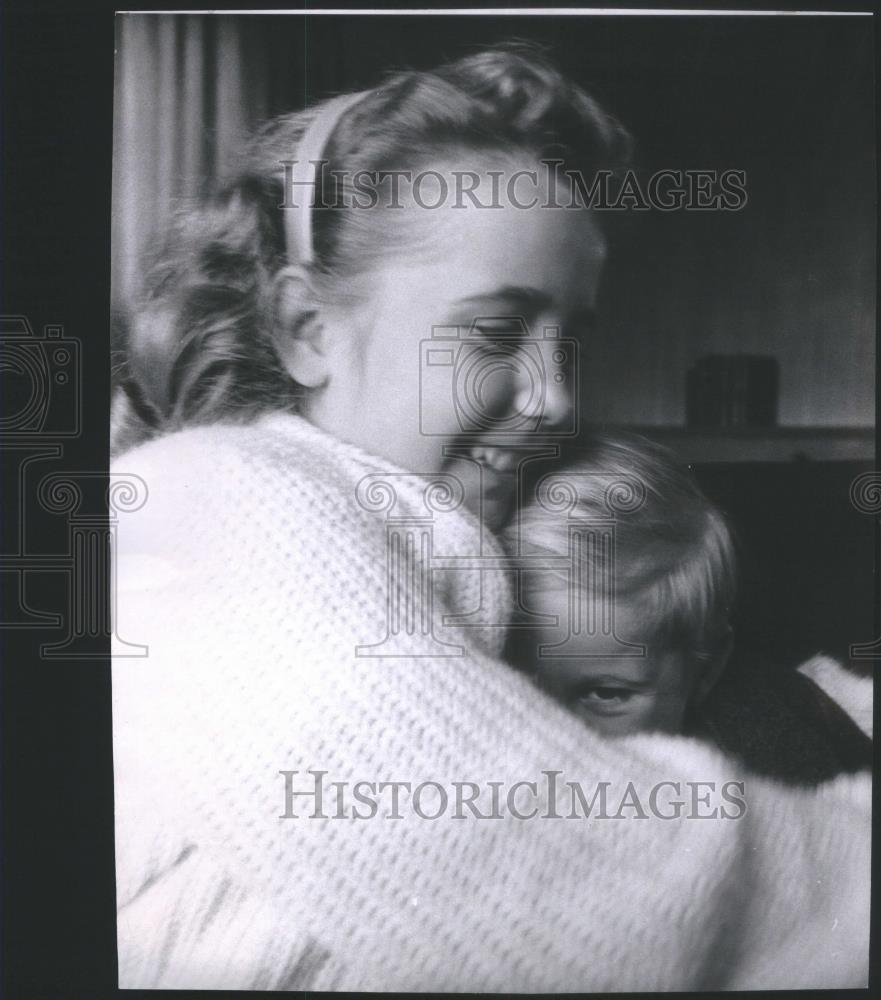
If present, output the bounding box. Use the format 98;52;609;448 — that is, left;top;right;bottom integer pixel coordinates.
111;15;267;312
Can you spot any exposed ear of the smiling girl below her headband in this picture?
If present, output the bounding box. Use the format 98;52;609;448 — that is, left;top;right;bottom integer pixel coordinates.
273;265;328;389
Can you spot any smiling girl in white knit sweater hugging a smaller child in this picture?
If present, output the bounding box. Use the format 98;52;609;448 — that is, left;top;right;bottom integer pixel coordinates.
113;49;869;991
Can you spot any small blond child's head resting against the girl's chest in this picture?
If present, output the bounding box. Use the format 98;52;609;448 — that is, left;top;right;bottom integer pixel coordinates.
508;436;734;734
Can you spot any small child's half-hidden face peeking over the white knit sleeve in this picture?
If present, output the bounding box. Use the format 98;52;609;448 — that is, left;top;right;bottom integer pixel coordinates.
528;583;696;735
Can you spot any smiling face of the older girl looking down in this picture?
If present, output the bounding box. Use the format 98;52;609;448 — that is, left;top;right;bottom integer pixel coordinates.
306;157;605;528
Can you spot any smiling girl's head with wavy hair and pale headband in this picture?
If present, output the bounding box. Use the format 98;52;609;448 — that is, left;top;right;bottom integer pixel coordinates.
117;47;628;532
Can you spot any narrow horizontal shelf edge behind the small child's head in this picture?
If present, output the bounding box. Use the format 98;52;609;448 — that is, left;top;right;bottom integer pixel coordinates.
596;424;875;464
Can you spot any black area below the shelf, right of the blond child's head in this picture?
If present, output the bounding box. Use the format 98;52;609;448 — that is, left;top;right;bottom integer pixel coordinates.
694;462;878;674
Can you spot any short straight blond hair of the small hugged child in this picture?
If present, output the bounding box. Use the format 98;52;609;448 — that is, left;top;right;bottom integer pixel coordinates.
506;434;735;659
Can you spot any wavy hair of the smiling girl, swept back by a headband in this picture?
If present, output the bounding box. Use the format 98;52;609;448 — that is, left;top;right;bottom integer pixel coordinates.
111;43;630;453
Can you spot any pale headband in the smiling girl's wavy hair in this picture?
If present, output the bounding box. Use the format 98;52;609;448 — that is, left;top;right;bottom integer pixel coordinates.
284;90;370;264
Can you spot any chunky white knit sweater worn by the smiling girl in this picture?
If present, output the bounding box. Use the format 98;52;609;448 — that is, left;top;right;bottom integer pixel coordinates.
113;415;870;991
